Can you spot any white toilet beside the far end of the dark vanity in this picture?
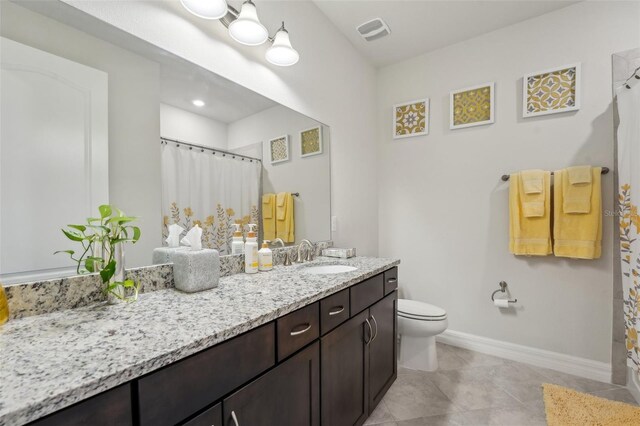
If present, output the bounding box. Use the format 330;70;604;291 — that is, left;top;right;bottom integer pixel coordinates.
398;299;448;371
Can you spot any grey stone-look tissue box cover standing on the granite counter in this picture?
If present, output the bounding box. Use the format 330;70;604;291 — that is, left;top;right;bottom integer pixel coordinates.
173;249;220;293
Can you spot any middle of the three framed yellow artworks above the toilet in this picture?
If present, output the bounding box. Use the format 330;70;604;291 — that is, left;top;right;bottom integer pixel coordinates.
449;83;494;129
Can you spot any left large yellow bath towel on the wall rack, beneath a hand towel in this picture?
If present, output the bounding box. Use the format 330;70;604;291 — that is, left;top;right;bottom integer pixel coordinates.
509;172;552;256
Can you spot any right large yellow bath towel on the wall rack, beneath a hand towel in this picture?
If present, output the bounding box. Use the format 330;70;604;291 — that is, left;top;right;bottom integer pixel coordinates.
553;167;602;259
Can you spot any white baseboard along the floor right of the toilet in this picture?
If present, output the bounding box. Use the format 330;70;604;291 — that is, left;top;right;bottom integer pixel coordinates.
436;330;611;383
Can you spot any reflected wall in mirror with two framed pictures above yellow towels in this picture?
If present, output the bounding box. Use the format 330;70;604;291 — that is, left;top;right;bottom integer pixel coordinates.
229;105;331;242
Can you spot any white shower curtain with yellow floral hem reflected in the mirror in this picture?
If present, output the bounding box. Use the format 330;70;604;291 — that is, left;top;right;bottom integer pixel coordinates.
161;142;261;255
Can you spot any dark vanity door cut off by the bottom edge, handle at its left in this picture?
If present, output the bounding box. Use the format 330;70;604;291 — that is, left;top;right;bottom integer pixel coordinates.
222;342;320;426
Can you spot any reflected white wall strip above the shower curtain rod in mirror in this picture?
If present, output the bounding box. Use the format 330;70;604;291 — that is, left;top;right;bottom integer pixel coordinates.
160;104;227;149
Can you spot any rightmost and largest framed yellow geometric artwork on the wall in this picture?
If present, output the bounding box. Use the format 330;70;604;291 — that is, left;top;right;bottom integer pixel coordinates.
523;64;580;117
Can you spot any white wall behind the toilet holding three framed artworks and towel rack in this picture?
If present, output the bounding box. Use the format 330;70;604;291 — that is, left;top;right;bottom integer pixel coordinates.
378;2;640;363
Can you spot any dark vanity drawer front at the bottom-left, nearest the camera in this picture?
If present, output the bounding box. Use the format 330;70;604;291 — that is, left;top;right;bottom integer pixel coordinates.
30;383;133;426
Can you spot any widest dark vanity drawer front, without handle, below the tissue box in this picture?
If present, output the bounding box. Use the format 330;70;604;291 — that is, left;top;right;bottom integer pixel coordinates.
138;322;276;426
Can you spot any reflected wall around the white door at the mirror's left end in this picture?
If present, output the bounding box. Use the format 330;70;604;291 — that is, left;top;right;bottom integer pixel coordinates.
0;1;162;267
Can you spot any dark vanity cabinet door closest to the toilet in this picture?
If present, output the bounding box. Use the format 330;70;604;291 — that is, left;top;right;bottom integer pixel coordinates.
369;291;398;412
